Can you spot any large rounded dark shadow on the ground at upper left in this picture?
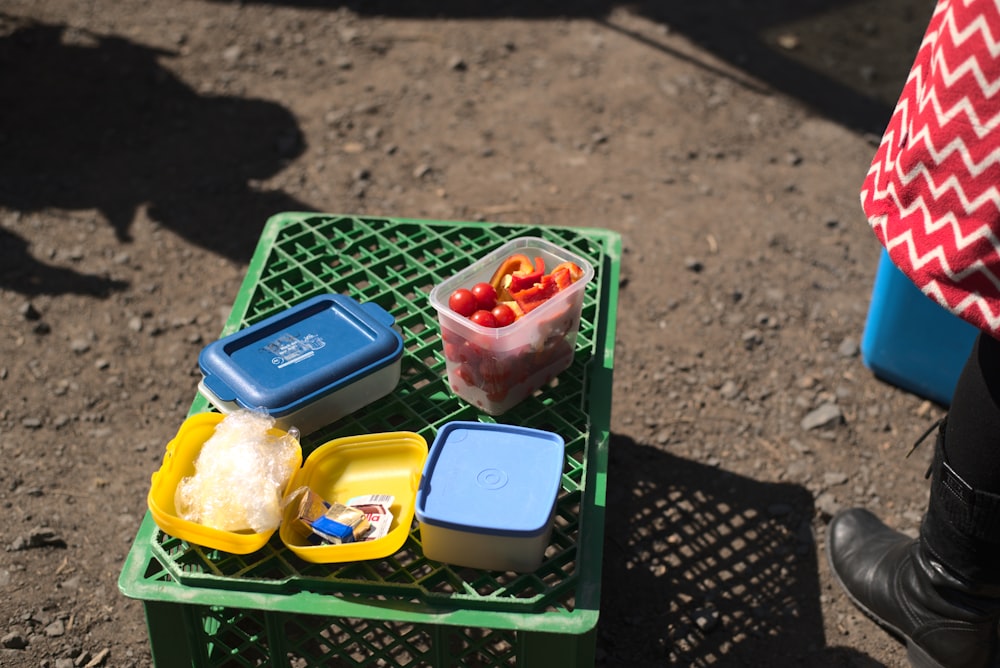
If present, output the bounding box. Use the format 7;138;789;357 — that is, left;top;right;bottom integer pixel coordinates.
0;15;310;280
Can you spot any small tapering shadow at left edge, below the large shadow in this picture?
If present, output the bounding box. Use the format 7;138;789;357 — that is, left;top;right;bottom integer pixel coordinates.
0;227;128;297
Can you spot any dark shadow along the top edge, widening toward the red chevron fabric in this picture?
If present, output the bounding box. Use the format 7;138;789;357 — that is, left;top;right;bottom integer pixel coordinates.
223;0;933;135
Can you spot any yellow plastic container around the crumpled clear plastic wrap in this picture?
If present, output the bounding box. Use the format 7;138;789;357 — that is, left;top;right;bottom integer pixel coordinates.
147;413;302;554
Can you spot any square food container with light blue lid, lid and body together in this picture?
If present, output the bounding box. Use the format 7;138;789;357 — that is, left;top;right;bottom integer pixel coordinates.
416;421;565;573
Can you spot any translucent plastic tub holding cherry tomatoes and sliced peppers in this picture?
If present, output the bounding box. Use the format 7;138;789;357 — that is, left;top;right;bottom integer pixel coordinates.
430;237;594;415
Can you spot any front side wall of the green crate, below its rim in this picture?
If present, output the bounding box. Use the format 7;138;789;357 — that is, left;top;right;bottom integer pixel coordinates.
145;602;596;668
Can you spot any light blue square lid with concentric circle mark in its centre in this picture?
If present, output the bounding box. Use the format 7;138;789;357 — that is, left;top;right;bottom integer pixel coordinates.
415;422;565;537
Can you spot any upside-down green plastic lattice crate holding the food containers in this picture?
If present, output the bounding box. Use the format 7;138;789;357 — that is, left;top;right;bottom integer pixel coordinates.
119;213;621;668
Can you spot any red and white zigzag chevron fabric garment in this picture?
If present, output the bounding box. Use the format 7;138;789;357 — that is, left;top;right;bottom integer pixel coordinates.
861;0;1000;338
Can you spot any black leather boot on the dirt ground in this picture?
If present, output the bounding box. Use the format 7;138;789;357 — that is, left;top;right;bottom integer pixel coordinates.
826;425;1000;668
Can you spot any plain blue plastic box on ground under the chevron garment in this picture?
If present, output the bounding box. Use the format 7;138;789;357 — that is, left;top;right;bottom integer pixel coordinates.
861;250;978;406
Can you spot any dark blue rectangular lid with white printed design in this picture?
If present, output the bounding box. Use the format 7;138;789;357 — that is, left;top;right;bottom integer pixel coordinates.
198;294;403;416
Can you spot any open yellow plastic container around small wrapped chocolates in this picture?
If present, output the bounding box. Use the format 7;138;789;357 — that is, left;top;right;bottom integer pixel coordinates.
278;431;427;564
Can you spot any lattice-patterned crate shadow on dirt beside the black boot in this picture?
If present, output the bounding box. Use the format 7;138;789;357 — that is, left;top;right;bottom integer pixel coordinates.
598;435;878;667
